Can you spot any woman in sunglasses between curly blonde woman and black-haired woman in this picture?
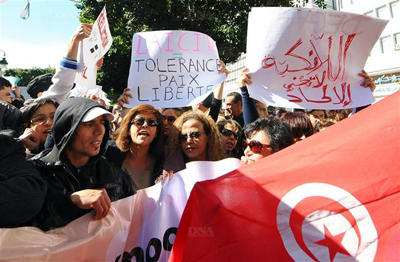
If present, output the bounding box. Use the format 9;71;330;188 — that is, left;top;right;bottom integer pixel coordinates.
217;119;242;159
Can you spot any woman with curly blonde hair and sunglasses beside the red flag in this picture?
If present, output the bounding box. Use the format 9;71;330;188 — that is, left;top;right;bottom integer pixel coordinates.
164;111;225;173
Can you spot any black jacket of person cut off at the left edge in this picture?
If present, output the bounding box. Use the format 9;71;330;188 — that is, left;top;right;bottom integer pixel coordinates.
0;131;47;227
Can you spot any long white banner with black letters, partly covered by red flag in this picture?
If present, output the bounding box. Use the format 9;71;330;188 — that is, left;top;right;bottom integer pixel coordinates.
0;158;243;261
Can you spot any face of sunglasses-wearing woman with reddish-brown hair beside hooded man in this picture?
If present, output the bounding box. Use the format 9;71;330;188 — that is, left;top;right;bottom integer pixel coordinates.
130;113;159;146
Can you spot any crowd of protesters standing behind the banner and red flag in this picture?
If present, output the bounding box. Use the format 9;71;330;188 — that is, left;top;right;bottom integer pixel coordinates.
0;24;374;230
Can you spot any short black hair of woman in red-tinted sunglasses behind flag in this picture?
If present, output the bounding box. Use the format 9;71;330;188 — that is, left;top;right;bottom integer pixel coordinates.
244;116;294;152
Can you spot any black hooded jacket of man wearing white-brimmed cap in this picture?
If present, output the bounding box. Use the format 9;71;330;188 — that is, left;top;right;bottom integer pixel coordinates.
31;97;135;230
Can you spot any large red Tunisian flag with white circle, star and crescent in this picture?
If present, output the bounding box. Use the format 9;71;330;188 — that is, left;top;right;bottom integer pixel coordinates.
170;92;400;261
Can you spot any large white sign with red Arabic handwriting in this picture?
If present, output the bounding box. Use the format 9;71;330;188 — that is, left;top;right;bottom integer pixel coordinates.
247;7;388;109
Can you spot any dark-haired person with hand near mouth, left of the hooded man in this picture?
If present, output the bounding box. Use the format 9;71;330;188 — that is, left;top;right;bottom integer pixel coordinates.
19;98;58;158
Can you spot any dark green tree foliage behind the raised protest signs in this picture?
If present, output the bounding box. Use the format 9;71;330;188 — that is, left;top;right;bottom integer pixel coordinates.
77;0;326;98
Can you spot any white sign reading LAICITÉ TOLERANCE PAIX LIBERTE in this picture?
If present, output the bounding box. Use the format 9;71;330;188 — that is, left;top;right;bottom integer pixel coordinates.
126;31;226;108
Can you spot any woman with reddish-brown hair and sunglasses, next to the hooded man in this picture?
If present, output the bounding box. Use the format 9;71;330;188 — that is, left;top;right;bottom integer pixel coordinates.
106;105;164;190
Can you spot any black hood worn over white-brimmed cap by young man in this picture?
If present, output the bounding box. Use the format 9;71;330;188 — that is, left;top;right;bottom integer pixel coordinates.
45;97;110;163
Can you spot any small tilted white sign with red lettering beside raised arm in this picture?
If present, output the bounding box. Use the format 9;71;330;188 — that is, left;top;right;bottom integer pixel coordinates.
75;7;113;89
